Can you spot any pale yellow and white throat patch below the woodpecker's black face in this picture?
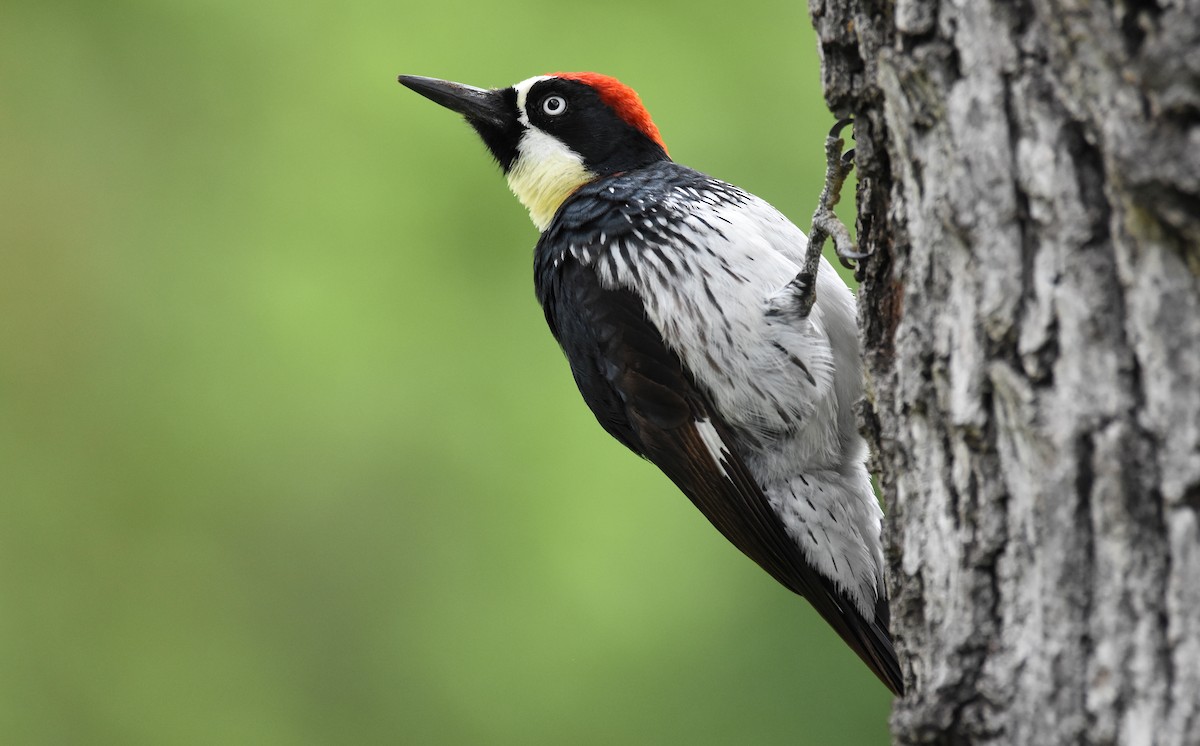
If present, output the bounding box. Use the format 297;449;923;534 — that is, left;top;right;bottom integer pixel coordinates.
508;127;596;230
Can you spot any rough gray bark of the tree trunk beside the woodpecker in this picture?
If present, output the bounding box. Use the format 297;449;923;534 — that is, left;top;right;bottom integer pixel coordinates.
810;0;1200;745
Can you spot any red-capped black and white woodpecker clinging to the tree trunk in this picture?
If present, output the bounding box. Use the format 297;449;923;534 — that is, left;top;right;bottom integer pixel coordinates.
400;73;904;693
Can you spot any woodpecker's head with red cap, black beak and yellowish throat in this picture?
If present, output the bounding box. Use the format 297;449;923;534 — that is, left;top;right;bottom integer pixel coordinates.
400;72;668;230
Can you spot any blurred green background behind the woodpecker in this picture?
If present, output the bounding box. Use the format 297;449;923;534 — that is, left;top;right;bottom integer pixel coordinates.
0;0;889;745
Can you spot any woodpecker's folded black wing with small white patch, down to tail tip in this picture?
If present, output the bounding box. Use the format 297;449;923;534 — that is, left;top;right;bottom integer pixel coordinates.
539;257;904;694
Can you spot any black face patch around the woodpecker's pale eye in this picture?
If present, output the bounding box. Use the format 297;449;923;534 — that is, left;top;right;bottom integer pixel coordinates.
520;78;667;176
